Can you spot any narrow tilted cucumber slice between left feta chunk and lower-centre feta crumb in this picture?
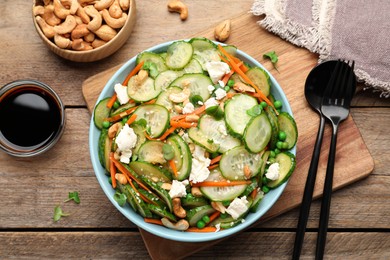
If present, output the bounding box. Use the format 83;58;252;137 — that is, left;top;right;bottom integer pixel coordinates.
129;161;172;182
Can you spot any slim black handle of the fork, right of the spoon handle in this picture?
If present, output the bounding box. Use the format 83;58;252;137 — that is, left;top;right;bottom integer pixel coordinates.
315;124;338;260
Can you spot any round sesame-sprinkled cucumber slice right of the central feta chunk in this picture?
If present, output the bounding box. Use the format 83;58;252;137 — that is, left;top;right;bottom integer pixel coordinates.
219;146;263;181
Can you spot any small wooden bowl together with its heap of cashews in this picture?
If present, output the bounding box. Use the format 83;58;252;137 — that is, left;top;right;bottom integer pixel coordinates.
32;0;136;62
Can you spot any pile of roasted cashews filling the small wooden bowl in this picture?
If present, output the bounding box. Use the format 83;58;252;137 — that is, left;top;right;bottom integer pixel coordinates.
33;0;130;51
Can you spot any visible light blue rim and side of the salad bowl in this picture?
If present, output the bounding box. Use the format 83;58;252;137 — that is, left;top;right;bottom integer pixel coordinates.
89;39;296;242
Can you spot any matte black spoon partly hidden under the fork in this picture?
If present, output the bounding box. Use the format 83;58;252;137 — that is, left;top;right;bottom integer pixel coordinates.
293;60;337;259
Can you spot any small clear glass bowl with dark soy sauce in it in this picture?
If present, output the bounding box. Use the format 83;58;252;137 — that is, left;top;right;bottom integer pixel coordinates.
0;80;65;157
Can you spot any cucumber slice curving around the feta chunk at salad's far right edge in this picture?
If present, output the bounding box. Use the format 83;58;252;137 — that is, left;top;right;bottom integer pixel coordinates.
267;152;296;188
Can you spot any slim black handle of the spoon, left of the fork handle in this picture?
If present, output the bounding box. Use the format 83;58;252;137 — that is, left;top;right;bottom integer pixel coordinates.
293;114;325;260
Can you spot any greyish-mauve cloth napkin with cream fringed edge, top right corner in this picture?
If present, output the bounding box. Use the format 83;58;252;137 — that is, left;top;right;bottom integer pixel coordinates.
251;0;390;97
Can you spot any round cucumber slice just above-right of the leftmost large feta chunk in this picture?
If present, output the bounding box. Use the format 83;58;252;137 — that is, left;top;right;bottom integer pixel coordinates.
134;104;169;138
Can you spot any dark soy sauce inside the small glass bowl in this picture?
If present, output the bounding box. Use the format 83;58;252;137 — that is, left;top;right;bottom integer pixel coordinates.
0;85;61;151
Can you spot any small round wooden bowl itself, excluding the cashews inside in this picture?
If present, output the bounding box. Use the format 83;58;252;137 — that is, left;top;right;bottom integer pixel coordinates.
33;0;136;62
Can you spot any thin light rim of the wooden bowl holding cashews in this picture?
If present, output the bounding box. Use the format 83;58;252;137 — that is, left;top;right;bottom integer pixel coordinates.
32;0;136;55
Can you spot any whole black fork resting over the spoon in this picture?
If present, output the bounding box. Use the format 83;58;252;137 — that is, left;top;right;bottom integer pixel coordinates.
316;60;356;259
